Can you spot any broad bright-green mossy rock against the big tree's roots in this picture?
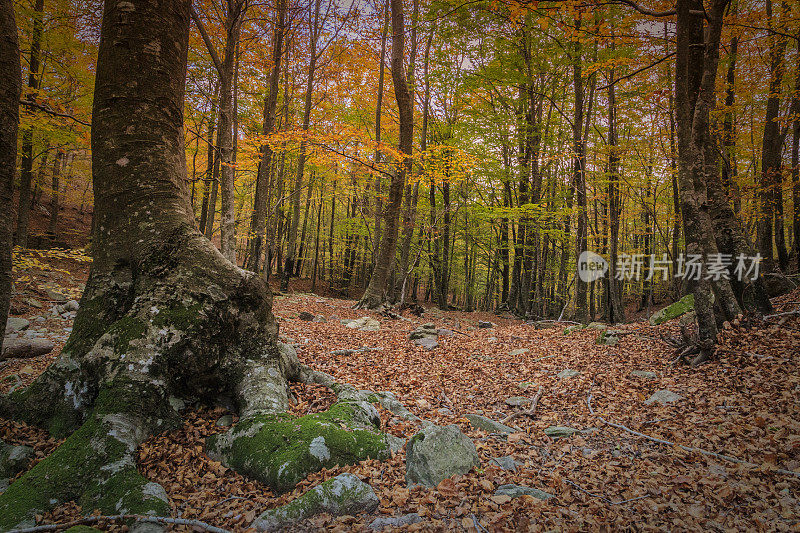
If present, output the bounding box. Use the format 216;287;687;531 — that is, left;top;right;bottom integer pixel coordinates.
206;401;389;492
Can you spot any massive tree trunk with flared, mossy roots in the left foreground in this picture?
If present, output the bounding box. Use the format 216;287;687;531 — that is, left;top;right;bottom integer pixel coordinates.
0;0;300;530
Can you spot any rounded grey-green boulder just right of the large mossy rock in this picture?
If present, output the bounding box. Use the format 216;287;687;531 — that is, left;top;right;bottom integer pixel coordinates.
406;424;480;487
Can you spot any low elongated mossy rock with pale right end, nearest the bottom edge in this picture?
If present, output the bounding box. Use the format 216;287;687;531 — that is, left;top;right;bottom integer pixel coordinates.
251;474;380;531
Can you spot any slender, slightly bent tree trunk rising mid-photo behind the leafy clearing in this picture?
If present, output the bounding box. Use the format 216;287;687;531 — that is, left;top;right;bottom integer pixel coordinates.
358;0;414;308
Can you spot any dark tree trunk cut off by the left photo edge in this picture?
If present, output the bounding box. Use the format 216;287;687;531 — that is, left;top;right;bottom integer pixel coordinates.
0;0;22;362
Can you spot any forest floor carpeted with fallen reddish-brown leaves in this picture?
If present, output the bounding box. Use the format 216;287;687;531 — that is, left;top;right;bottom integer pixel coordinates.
0;247;800;532
